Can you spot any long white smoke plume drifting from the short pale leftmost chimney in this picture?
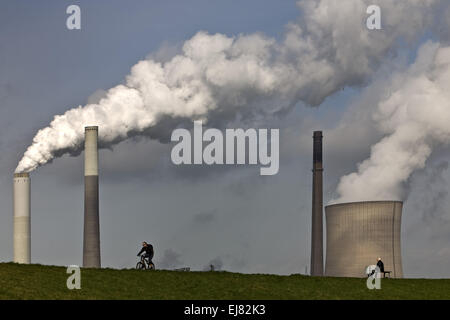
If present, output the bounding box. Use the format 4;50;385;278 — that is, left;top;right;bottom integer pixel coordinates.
16;0;440;172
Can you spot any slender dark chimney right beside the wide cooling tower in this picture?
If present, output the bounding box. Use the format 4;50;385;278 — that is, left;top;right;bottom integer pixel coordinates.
311;131;323;276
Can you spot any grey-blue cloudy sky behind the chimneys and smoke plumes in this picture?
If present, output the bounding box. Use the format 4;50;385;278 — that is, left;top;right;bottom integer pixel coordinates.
0;0;450;277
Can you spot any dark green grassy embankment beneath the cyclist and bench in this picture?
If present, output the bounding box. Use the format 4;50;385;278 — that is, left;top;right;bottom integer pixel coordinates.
0;263;450;300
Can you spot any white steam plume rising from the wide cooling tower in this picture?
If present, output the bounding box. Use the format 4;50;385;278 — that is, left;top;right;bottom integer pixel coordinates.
332;42;450;202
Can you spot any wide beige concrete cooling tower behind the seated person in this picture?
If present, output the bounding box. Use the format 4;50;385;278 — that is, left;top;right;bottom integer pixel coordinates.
325;201;403;278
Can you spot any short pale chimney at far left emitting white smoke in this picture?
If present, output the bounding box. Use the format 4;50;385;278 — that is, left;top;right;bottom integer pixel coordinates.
13;173;31;263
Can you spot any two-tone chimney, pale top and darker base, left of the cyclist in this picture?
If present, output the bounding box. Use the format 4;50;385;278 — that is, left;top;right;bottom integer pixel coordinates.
83;127;100;268
